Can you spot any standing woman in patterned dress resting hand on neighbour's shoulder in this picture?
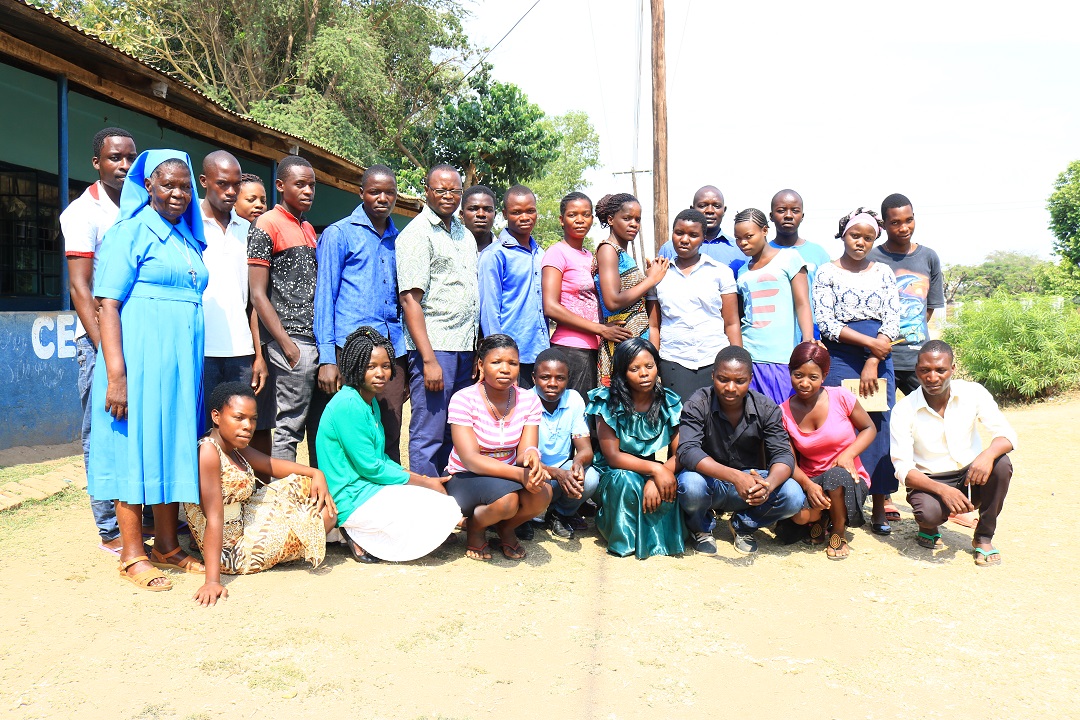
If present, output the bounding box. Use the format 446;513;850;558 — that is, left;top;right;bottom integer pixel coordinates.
592;192;669;388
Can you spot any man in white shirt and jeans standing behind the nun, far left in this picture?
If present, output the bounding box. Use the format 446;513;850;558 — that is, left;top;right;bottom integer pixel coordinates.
60;127;138;555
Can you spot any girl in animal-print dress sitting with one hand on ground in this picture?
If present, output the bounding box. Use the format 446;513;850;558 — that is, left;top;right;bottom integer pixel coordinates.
184;382;337;607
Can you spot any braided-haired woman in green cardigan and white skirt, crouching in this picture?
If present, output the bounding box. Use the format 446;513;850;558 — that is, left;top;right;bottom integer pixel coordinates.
315;326;461;562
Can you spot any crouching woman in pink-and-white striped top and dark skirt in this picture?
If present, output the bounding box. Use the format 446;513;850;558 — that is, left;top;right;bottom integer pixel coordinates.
446;334;551;560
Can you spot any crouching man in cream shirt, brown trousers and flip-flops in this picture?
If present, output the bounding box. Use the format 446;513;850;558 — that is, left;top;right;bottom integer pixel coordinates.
891;340;1016;567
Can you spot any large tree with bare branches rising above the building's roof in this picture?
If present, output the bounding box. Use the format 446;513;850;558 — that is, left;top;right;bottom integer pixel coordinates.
43;0;473;167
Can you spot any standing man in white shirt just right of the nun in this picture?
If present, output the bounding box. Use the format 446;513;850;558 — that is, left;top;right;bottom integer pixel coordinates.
199;150;269;426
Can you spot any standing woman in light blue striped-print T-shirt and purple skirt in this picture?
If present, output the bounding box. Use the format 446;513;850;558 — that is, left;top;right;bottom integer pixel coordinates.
735;207;813;405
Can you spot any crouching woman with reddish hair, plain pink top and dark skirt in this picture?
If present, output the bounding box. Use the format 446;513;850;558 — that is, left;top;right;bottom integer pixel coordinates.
780;342;877;560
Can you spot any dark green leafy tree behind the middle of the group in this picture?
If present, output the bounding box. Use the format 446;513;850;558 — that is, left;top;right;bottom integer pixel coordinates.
431;67;558;198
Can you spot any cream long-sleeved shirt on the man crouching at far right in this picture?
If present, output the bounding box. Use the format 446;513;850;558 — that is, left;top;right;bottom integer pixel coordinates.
890;380;1016;483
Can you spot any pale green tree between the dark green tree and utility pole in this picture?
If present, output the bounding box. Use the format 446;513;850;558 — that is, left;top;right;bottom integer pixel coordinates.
526;111;600;247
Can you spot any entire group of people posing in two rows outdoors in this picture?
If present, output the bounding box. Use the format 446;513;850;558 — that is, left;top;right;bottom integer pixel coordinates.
60;127;1016;604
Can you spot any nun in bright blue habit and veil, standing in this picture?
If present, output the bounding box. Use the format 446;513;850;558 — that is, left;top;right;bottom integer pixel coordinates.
86;150;208;592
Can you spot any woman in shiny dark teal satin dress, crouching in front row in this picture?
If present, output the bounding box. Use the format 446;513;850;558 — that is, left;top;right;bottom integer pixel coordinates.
585;338;686;559
